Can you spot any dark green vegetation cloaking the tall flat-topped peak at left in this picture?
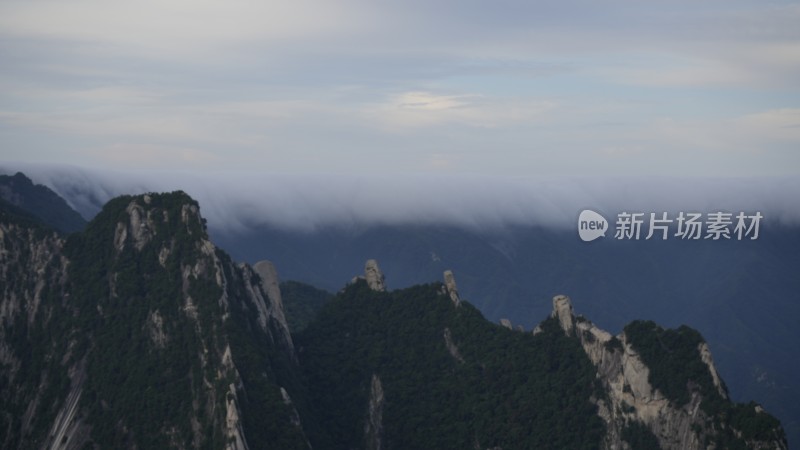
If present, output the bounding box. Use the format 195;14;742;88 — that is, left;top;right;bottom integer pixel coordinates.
65;192;303;448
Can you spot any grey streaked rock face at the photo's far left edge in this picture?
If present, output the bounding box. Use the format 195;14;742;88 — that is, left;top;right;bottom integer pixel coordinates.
0;211;75;448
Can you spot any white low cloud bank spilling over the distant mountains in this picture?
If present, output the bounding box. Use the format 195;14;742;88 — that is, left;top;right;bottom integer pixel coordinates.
0;163;800;232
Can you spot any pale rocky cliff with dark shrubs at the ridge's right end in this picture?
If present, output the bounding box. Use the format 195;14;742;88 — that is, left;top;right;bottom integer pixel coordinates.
552;295;788;450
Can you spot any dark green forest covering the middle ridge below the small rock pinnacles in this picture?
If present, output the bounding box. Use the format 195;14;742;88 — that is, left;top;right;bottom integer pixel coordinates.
297;281;604;449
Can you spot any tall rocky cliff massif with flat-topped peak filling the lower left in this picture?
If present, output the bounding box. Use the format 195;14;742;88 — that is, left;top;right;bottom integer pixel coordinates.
0;192;307;449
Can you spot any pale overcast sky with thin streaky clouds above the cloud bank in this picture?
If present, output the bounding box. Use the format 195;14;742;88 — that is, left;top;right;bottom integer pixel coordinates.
0;0;800;179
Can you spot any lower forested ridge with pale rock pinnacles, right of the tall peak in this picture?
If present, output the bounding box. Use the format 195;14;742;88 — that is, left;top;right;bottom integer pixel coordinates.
299;261;787;449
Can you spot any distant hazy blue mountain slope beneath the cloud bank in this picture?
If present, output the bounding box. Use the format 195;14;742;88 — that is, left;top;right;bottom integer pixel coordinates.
212;220;800;441
